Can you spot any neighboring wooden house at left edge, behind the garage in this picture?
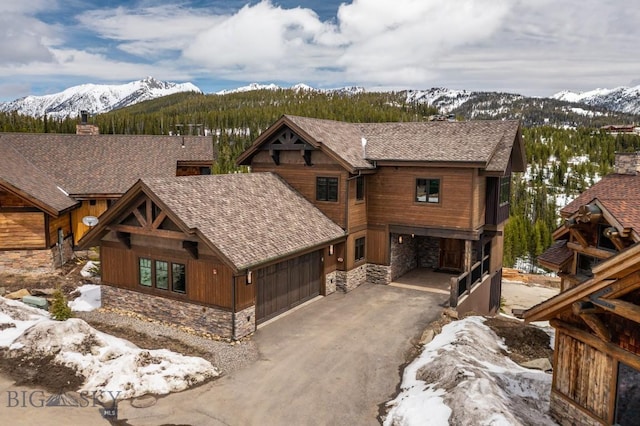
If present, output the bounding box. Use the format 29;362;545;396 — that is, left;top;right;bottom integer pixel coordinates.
0;133;214;272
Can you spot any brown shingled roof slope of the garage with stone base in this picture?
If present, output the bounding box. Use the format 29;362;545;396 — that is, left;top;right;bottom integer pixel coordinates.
141;173;345;270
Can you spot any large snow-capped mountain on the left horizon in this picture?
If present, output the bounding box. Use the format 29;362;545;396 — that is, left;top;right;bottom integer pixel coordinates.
0;77;202;118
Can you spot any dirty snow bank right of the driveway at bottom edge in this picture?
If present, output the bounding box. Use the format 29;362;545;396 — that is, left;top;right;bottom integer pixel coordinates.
384;316;556;426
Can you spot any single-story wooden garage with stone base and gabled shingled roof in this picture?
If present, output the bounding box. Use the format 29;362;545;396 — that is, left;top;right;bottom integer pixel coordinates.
81;173;345;338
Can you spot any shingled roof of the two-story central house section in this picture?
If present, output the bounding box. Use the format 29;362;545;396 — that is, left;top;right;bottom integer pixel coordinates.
238;115;525;172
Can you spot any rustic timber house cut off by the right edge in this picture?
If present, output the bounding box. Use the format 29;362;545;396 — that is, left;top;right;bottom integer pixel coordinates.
524;153;640;425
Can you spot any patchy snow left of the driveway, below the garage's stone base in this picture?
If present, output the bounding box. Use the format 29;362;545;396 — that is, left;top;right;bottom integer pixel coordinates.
0;296;219;399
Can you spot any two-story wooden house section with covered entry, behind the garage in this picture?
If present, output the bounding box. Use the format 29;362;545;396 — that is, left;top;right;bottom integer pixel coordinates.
237;115;526;313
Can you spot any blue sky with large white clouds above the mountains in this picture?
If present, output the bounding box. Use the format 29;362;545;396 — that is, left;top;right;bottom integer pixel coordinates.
0;0;640;101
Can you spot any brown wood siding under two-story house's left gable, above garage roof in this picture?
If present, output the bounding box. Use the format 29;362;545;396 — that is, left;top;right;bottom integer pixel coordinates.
251;151;355;228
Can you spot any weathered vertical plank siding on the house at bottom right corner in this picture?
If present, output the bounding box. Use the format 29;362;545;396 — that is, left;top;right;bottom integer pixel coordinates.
553;331;615;422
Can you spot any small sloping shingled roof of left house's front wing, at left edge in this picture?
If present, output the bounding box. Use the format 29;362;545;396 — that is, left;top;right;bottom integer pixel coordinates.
0;138;78;216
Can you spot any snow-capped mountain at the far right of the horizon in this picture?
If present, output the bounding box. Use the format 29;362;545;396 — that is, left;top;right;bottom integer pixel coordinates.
552;86;640;114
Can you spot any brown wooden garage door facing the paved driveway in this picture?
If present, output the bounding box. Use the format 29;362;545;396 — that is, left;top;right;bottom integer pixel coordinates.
254;251;322;324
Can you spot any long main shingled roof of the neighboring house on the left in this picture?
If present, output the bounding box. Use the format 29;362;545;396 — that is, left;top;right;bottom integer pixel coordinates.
0;133;213;196
